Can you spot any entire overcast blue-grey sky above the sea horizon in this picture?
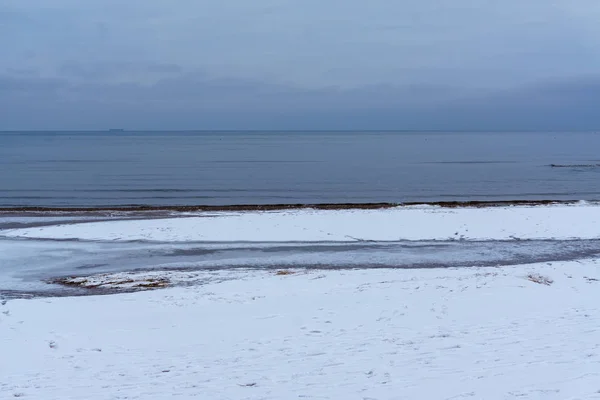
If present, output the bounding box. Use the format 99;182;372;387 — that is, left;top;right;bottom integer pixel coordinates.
0;0;600;130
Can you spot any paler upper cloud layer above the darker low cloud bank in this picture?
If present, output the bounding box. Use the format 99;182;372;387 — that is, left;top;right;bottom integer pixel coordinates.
0;0;600;88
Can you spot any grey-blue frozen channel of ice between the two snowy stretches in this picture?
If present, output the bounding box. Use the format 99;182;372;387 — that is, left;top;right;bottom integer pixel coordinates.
0;239;600;295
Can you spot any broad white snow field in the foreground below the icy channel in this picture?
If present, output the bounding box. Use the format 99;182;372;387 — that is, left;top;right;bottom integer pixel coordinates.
0;259;600;400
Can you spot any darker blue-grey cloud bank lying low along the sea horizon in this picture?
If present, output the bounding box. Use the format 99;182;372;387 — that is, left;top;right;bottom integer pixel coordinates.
0;74;600;130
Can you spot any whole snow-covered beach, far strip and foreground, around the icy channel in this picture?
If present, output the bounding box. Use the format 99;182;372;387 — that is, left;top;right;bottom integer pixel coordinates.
0;203;600;399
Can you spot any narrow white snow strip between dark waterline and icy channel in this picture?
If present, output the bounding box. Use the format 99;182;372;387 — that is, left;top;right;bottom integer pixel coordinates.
2;203;600;242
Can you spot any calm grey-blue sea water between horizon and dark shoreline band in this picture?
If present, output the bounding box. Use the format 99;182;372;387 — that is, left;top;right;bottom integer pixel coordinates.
0;132;600;207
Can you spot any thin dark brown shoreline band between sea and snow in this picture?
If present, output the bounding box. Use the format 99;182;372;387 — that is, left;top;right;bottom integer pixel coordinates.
0;200;600;215
